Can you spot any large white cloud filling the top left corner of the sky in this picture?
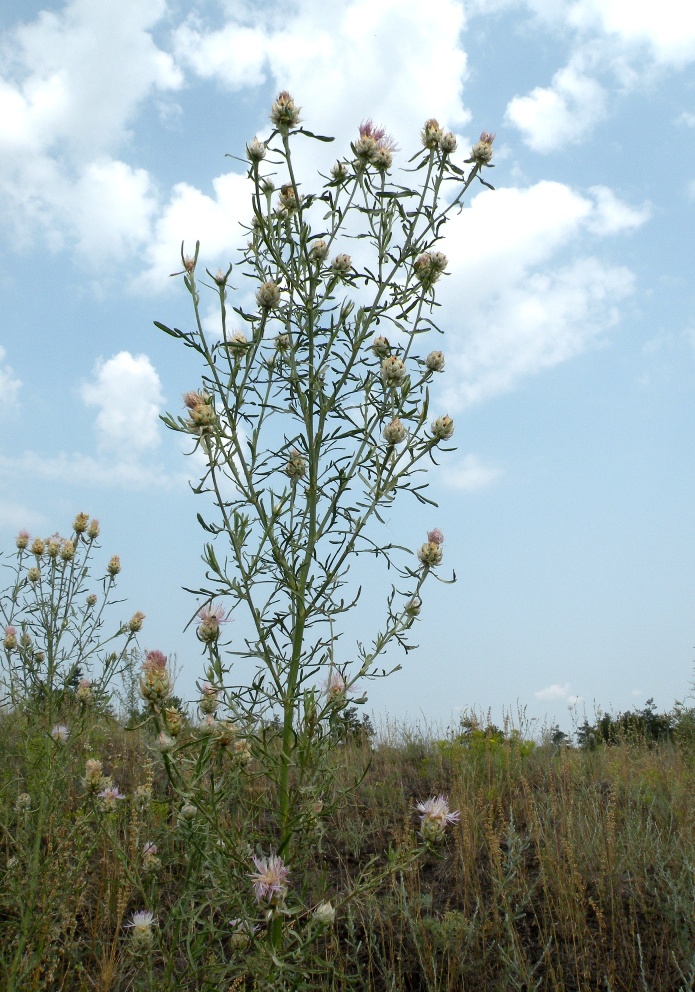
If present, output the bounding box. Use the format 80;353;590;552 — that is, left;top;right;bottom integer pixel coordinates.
0;0;183;262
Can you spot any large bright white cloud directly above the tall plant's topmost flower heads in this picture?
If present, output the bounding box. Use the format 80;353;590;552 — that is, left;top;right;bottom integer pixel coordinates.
176;0;470;158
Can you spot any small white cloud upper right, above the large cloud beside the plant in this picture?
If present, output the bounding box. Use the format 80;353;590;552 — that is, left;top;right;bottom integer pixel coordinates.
506;63;606;152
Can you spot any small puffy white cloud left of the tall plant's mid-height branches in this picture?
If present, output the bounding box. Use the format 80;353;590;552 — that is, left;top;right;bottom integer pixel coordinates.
80;351;163;465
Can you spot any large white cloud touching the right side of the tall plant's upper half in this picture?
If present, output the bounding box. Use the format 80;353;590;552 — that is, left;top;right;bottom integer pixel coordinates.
439;182;647;404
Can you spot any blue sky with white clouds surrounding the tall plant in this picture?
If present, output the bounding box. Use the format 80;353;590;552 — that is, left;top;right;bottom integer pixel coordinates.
0;0;695;728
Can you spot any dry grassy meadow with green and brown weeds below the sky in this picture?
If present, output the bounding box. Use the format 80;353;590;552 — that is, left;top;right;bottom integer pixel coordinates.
0;700;695;992
